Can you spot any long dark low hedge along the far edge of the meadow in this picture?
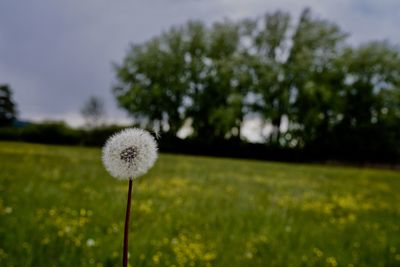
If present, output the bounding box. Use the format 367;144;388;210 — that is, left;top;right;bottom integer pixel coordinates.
0;122;400;164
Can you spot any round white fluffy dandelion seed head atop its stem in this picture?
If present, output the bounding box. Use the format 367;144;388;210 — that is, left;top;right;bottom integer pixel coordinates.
102;128;157;180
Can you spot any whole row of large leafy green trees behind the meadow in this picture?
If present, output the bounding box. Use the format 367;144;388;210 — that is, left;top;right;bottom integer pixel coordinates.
113;9;400;161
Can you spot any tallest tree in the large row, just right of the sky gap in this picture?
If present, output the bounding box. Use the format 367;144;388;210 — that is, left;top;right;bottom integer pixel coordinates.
286;9;347;147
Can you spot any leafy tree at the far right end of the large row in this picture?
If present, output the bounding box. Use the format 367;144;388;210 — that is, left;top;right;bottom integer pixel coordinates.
334;42;400;158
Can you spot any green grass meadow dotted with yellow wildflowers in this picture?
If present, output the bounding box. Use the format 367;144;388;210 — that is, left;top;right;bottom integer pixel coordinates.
0;142;400;267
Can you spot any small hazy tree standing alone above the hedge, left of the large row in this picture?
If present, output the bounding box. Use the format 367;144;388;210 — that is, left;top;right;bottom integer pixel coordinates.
81;96;105;128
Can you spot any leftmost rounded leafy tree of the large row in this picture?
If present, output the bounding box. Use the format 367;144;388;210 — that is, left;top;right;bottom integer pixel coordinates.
113;28;187;135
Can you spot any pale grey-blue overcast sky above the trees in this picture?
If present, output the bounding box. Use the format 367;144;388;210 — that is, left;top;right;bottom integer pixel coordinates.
0;0;400;125
